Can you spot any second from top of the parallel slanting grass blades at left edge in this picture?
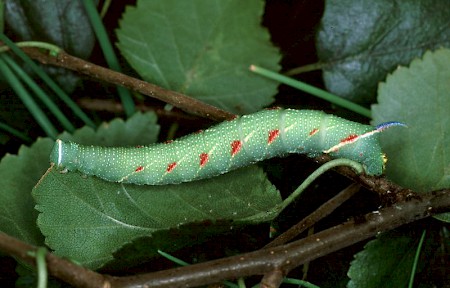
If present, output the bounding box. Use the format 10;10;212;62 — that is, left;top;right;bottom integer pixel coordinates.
3;54;75;132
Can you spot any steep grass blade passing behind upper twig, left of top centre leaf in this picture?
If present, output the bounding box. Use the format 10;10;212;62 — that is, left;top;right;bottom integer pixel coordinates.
83;0;135;117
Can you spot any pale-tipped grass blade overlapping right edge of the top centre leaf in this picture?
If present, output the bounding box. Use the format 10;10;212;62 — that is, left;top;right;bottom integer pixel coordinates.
250;65;372;118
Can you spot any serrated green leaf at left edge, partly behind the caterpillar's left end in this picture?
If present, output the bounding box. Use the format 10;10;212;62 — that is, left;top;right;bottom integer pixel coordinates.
0;113;159;245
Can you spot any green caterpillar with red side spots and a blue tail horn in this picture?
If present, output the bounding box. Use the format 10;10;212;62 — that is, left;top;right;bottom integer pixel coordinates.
50;108;404;185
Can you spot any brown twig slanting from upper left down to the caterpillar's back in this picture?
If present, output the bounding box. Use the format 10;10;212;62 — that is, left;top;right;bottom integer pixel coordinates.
22;48;235;121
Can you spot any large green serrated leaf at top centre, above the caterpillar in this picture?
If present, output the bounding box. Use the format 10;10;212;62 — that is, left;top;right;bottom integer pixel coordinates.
117;0;280;114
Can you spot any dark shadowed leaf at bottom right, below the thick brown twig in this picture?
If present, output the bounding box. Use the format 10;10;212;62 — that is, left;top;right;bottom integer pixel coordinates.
347;232;418;288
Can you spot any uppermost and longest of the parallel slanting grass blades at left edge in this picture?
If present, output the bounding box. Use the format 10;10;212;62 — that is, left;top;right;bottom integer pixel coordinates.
0;33;96;128
